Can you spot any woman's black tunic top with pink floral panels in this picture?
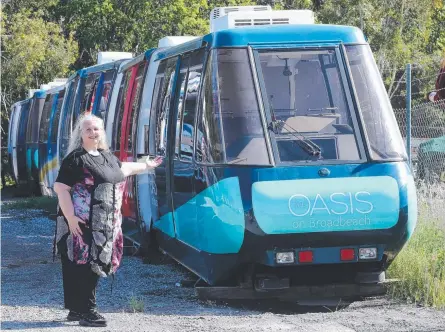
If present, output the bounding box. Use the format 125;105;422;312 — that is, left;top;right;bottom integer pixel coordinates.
55;148;125;276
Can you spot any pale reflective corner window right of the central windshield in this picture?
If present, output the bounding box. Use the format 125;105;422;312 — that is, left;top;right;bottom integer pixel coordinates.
346;45;407;160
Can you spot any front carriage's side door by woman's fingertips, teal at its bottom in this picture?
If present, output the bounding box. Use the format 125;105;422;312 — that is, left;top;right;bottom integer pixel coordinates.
149;57;178;237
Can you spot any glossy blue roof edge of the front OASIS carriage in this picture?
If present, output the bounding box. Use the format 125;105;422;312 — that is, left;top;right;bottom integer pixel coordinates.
155;24;367;60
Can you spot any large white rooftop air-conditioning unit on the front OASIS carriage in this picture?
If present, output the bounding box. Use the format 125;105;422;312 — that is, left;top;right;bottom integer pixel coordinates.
210;7;315;32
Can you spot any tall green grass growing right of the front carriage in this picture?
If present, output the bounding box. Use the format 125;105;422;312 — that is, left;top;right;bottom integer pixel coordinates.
388;182;445;309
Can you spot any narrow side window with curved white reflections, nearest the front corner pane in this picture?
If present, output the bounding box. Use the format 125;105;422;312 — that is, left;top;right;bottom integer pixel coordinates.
180;49;205;161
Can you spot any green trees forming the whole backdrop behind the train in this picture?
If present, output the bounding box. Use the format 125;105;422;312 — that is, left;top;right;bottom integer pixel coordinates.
1;0;445;139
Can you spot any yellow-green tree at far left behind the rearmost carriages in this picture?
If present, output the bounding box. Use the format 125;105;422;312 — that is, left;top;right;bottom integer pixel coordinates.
1;10;77;141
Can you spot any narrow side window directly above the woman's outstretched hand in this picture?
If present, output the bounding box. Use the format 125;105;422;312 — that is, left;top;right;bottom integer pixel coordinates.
150;57;178;156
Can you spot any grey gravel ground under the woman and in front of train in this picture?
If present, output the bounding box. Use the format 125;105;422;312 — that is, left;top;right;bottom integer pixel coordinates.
1;206;445;332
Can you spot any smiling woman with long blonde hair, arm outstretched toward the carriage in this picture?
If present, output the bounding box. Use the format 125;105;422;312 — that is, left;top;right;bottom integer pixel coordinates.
54;115;162;326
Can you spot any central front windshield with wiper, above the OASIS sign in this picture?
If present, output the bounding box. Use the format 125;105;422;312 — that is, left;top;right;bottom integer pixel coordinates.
258;49;362;163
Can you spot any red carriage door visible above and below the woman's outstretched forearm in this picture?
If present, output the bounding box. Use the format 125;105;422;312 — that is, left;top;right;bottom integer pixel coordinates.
119;61;147;222
